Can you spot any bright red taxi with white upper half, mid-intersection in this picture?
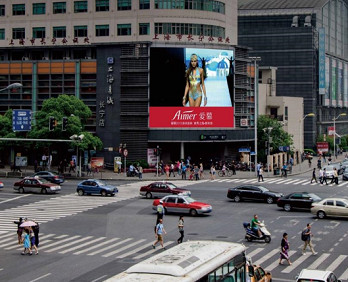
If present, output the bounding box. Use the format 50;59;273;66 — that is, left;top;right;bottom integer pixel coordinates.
152;195;213;216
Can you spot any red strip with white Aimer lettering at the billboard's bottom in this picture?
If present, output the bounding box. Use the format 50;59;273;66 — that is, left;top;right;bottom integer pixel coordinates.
150;107;234;128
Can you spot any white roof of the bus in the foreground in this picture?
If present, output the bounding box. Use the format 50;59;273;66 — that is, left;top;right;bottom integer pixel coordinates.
125;241;245;277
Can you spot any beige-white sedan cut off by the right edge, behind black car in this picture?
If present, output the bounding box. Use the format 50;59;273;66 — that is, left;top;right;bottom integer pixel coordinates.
311;198;348;218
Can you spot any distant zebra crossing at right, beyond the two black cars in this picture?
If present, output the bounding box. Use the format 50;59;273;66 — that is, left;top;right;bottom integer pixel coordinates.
209;177;348;187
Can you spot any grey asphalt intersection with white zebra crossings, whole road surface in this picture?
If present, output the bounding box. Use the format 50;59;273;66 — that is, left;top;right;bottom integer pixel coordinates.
0;172;348;282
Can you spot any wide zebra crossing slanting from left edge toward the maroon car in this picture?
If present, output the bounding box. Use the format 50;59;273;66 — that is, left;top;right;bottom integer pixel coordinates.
0;180;204;233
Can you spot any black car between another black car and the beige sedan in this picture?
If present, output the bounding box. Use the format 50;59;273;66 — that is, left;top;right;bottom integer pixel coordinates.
277;192;321;211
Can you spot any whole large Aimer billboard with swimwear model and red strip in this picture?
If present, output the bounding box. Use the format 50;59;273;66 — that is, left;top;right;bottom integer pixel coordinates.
149;48;234;129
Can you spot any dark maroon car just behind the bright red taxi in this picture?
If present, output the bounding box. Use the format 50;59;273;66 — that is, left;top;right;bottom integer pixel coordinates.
140;182;191;199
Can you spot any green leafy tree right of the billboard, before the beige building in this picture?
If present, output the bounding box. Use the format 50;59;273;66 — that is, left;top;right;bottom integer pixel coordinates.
257;115;293;163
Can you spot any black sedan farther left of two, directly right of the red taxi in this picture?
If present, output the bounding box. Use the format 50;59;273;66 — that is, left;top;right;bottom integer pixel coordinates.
227;185;283;204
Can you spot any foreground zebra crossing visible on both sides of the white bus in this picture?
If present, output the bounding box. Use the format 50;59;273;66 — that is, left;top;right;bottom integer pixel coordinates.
0;232;348;281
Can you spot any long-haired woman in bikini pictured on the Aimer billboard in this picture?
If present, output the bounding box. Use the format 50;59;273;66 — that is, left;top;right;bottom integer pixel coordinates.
182;54;208;107
